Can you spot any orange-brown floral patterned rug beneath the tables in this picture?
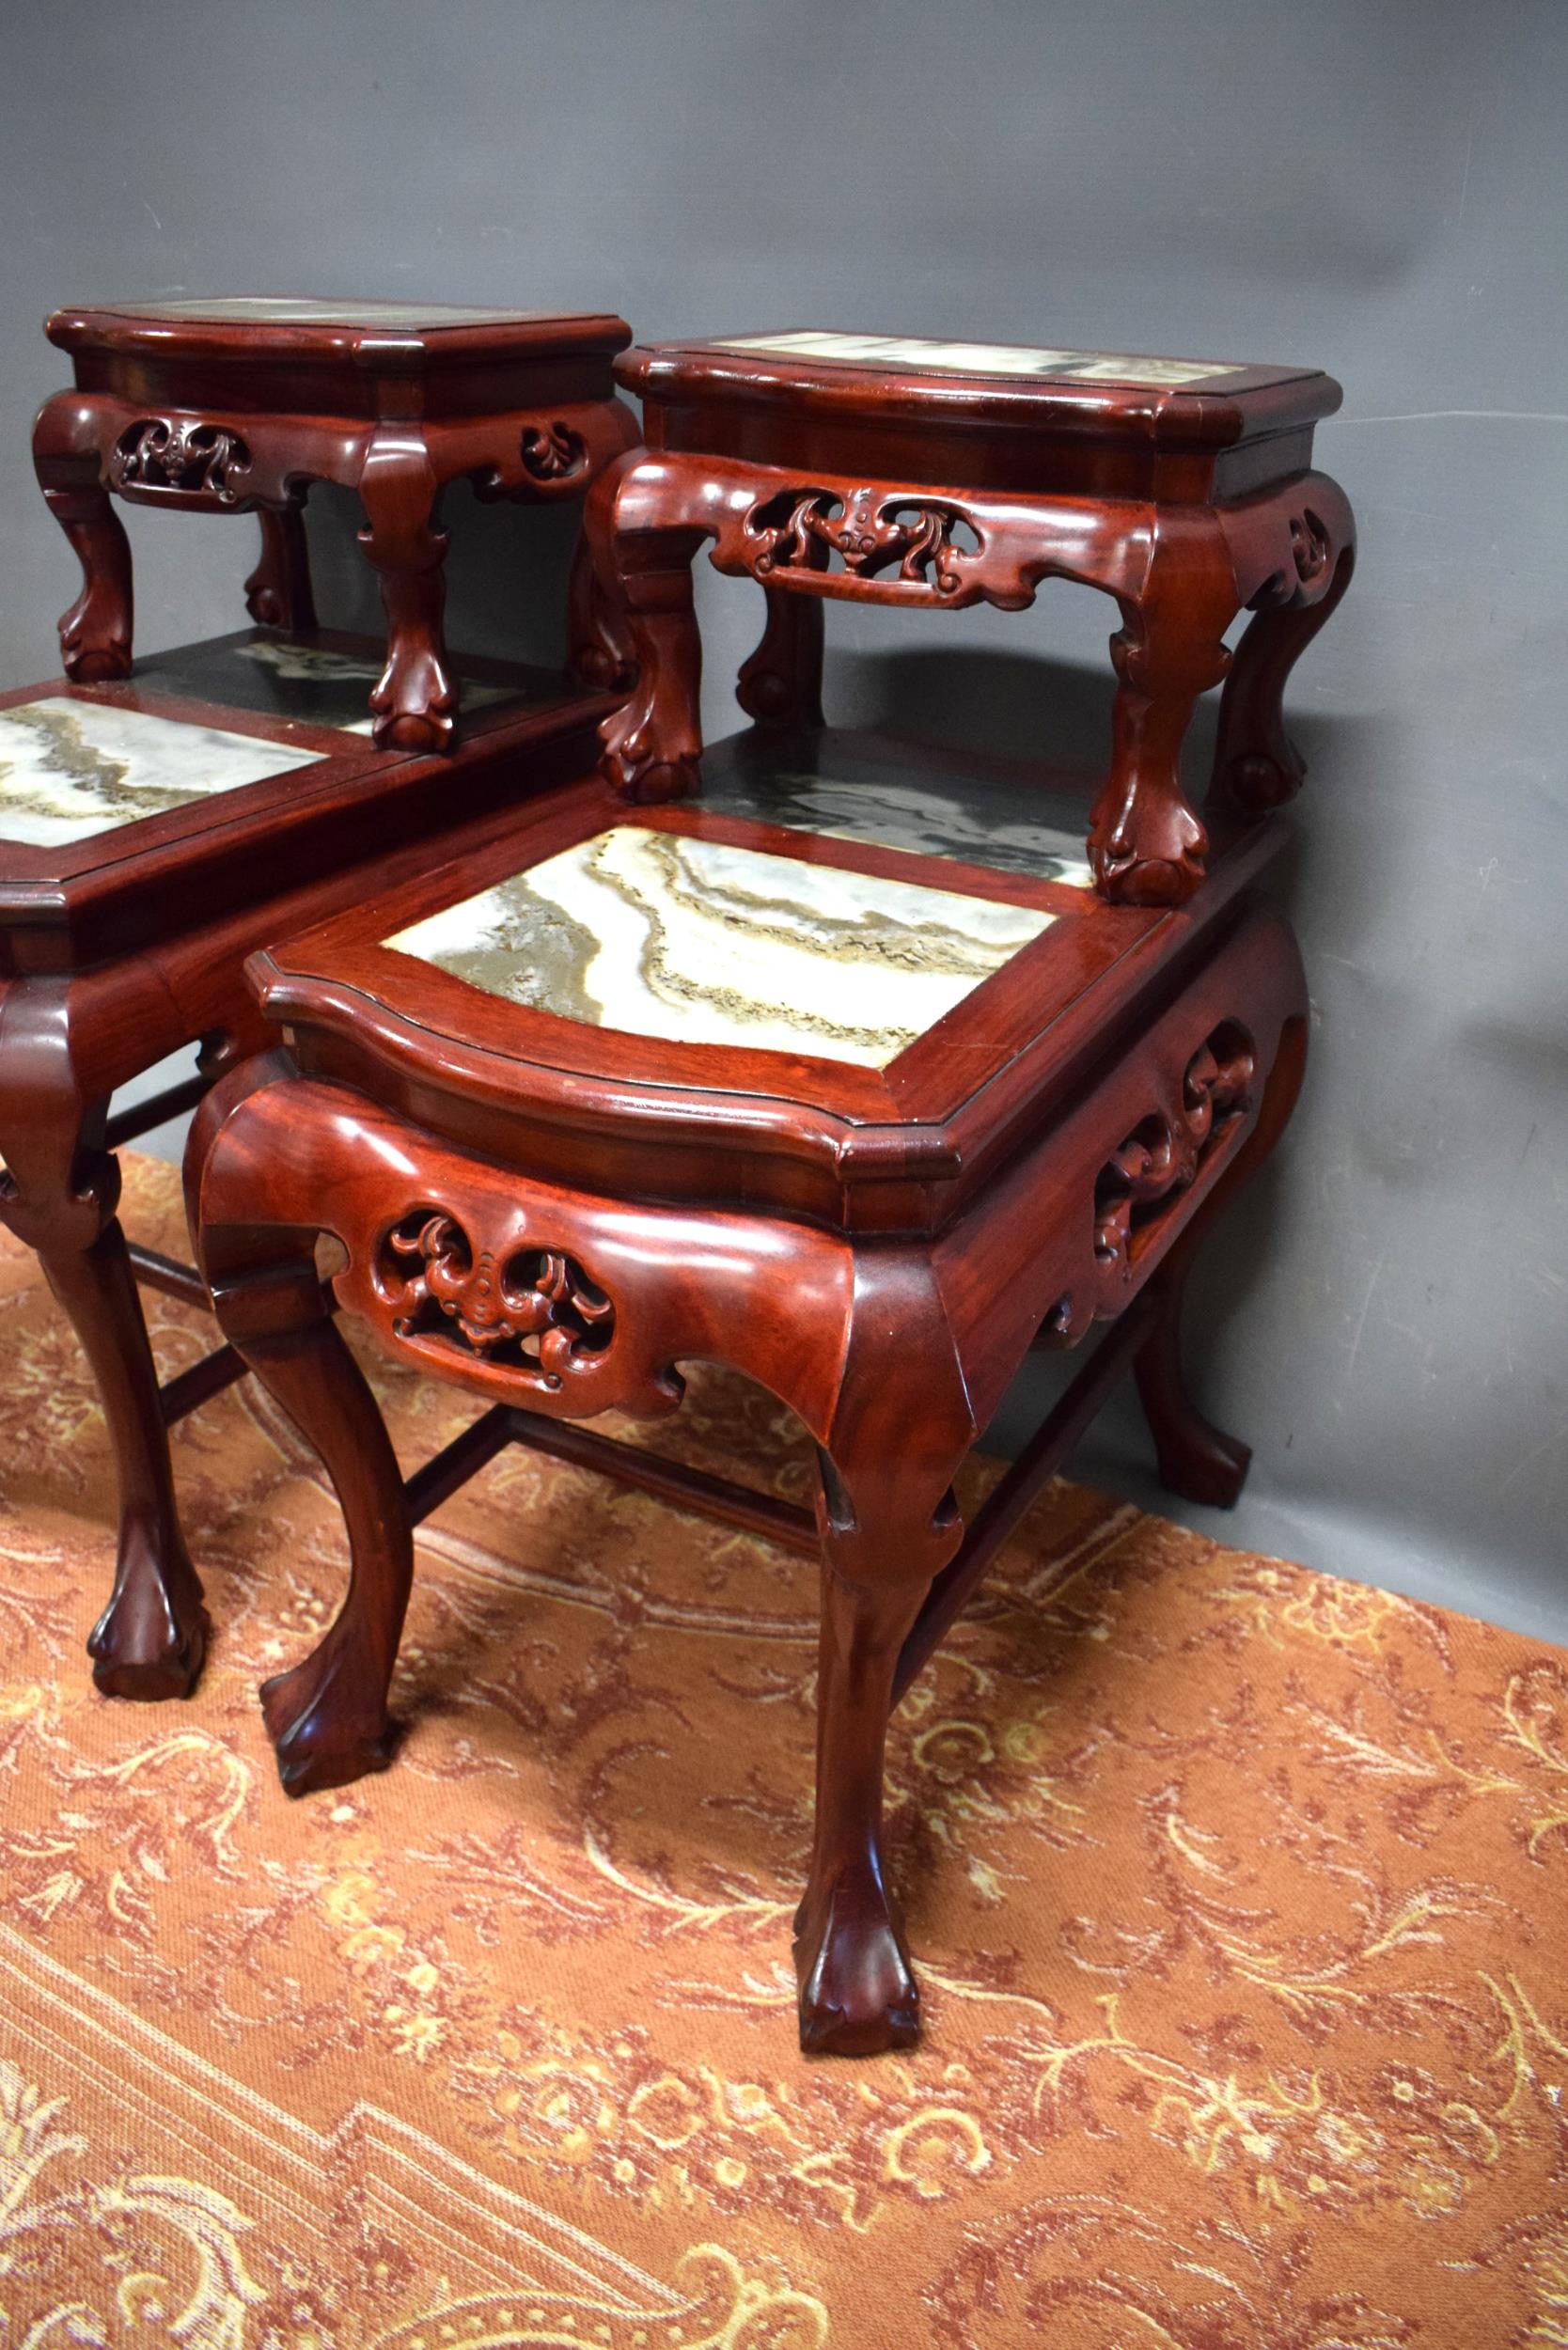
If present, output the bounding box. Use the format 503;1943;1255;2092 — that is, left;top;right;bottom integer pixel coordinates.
0;1166;1568;2350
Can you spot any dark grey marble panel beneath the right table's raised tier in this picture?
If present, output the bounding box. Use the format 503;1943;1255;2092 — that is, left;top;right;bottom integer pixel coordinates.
700;766;1093;888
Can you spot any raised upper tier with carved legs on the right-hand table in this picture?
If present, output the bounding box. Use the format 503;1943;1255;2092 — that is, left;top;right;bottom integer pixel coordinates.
588;329;1354;905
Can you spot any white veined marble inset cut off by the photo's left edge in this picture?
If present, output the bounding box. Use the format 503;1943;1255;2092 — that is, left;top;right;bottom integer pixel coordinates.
0;694;322;849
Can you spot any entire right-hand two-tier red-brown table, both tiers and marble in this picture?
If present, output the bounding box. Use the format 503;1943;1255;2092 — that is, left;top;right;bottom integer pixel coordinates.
186;337;1349;2054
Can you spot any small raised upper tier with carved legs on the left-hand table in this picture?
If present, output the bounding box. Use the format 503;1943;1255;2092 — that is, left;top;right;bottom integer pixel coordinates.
33;299;637;752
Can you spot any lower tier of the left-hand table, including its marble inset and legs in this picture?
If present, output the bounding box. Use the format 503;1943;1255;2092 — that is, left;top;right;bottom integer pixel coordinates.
0;630;611;1697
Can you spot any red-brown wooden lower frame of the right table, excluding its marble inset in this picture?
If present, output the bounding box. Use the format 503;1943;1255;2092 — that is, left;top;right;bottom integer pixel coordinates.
186;757;1305;2054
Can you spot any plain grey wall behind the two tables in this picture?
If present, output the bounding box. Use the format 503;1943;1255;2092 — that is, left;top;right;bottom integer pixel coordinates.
0;0;1568;1638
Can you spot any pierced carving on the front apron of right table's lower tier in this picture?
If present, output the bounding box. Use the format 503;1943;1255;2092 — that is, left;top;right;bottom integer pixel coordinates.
376;1208;616;1389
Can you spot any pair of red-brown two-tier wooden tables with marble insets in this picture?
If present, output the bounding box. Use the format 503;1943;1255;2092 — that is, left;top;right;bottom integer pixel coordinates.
0;304;1354;2054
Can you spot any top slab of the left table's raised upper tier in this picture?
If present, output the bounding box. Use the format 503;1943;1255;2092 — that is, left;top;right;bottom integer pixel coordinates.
45;294;633;369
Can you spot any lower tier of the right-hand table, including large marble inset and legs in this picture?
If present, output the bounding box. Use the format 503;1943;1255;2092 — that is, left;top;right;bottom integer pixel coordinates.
186;747;1307;2054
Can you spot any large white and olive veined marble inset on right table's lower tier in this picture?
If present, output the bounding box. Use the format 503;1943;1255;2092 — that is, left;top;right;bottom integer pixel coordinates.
385;825;1053;1070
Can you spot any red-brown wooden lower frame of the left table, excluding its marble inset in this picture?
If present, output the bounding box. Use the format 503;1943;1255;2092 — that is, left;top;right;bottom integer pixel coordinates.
0;644;606;1700
